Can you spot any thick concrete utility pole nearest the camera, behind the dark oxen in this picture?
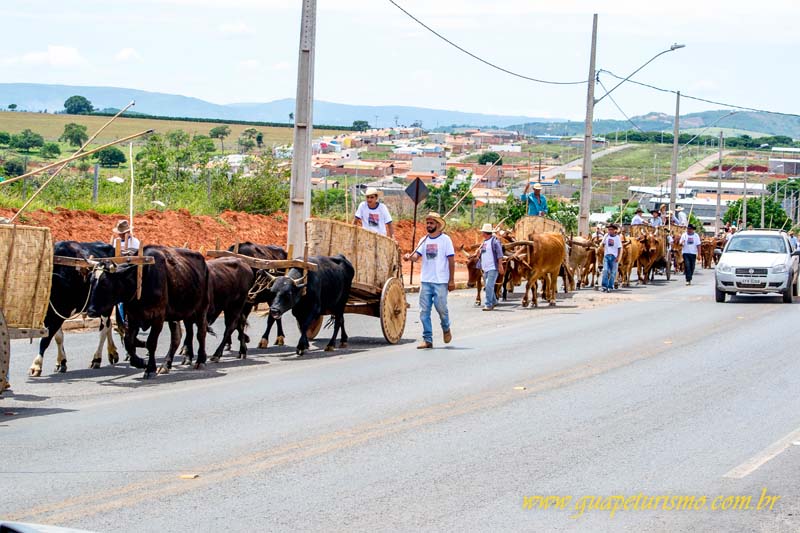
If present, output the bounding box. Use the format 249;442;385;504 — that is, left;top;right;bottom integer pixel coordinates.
286;0;317;259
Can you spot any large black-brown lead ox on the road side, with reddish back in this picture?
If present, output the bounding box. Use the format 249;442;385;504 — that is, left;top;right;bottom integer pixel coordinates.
88;246;211;379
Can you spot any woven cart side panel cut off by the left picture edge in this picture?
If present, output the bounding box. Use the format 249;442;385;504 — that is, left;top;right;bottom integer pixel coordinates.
0;224;53;328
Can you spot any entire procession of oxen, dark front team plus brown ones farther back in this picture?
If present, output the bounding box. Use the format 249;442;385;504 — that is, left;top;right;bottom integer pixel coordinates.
29;227;724;378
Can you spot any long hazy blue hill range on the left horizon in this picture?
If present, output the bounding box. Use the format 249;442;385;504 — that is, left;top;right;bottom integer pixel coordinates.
0;83;564;128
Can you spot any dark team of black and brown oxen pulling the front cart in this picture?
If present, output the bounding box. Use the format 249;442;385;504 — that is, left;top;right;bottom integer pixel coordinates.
29;241;354;378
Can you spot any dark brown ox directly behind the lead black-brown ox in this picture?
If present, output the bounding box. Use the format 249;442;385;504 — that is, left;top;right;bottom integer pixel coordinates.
182;257;253;364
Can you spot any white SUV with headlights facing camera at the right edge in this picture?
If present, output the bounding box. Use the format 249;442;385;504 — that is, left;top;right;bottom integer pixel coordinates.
715;230;800;303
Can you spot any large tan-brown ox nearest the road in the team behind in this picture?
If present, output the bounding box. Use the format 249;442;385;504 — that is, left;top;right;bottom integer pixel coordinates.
506;233;566;307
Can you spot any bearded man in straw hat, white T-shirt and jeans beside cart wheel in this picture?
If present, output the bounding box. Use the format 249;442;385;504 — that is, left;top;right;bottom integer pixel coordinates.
403;213;456;349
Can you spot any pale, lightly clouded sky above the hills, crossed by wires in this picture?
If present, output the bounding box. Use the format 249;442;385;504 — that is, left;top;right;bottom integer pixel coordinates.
0;0;800;121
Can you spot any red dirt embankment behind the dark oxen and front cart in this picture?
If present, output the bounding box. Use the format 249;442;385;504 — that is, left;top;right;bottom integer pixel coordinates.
0;209;481;262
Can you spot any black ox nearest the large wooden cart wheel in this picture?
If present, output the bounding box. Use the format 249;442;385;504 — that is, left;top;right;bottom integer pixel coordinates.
265;254;355;355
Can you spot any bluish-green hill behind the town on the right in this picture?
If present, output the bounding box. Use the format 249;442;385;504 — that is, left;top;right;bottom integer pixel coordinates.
508;111;800;139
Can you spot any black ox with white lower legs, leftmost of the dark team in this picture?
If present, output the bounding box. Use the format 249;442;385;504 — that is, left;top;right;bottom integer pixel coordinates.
28;241;119;377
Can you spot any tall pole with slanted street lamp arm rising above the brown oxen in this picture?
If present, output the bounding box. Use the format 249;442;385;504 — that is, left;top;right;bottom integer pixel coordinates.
578;20;686;235
